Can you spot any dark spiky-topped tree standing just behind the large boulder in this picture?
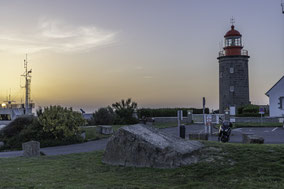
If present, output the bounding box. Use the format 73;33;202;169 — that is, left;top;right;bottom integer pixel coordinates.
112;98;138;124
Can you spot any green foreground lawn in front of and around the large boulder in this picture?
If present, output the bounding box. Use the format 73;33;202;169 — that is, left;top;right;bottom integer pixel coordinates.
0;142;284;189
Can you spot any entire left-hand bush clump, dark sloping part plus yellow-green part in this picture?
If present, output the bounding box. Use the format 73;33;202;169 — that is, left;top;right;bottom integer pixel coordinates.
0;106;85;149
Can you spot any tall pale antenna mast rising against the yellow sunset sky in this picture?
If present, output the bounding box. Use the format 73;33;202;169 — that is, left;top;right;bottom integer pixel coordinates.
22;54;32;115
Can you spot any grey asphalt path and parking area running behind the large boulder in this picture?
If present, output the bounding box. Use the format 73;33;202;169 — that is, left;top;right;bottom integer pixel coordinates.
0;125;284;158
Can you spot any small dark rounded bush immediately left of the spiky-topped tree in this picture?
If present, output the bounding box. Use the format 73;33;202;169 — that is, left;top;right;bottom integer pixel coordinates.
90;106;116;125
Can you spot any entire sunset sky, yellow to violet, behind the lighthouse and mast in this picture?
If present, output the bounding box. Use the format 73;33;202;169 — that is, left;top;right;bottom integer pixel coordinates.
0;0;284;112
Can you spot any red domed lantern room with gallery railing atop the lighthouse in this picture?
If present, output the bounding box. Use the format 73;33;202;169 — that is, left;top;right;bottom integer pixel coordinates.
219;25;248;56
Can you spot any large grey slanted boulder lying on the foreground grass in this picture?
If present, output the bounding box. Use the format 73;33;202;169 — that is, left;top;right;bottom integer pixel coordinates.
102;125;203;168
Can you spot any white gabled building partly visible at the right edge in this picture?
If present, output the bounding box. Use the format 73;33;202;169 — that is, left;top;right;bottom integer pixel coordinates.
265;76;284;117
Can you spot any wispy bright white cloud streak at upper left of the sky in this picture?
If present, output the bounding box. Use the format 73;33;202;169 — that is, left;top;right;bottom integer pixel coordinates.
0;19;117;53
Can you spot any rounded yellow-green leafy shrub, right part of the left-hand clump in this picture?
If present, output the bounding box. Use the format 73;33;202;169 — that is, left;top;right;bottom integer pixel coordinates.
38;106;85;140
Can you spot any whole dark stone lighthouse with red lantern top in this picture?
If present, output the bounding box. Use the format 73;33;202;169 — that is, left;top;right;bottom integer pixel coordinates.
218;25;250;113
